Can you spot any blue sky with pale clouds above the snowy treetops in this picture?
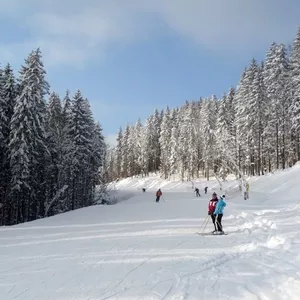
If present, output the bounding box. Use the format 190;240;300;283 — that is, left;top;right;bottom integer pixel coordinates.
0;0;300;143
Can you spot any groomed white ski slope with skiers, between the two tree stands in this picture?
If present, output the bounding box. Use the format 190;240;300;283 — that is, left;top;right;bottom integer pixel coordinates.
0;165;300;300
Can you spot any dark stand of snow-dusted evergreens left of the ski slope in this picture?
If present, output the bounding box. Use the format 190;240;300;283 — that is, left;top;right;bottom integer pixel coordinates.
0;49;105;225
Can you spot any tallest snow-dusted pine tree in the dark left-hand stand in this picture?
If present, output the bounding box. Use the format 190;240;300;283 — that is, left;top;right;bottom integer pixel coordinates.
9;49;49;224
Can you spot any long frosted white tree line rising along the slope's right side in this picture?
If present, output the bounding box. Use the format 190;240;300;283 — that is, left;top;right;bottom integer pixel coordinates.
105;28;300;180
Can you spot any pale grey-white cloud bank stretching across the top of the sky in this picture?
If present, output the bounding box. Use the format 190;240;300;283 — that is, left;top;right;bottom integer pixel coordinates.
0;0;300;67
